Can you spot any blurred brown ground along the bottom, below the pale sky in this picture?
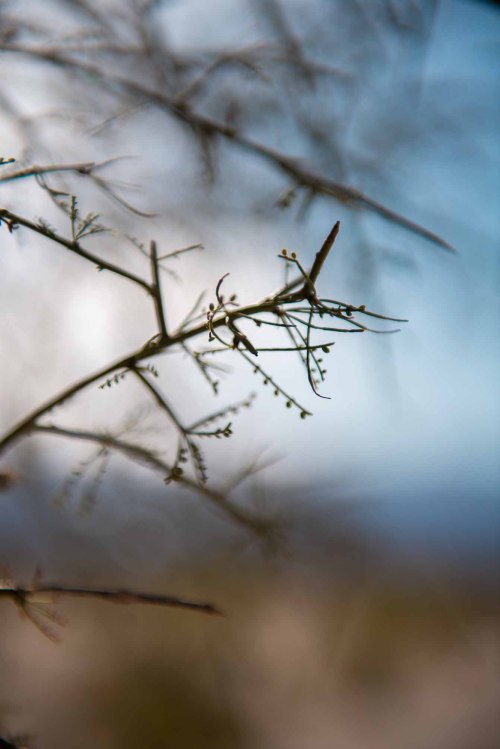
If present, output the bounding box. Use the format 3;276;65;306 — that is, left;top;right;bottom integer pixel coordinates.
0;486;500;749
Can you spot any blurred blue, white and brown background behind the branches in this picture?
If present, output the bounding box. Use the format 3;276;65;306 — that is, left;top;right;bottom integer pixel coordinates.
0;0;500;749
